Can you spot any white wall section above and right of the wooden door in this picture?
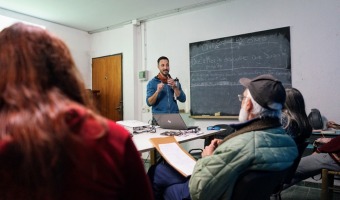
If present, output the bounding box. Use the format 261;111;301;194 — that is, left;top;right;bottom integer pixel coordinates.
91;25;142;120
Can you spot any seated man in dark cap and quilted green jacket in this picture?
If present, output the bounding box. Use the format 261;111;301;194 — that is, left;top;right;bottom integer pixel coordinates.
148;74;298;200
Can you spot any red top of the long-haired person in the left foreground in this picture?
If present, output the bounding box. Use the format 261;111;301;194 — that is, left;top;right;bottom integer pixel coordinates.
0;106;153;200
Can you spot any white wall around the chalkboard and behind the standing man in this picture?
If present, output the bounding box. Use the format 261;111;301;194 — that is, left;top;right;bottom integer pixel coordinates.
92;0;340;149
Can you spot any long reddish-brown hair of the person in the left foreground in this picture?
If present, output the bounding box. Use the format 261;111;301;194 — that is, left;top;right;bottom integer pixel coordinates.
0;23;102;200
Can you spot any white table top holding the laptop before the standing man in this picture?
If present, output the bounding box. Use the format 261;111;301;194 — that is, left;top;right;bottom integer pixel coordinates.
132;127;224;164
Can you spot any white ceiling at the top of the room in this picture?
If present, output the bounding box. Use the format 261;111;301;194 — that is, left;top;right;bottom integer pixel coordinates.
0;0;227;33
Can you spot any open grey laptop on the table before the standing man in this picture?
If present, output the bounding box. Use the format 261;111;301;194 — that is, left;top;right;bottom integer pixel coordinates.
153;113;198;130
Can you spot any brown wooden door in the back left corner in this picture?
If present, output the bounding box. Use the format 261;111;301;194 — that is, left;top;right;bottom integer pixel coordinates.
92;54;123;121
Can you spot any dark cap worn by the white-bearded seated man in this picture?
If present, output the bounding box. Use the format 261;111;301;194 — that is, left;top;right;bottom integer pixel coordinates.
240;74;286;110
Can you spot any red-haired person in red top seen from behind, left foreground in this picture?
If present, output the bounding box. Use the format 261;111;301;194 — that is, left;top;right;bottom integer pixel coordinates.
0;23;153;200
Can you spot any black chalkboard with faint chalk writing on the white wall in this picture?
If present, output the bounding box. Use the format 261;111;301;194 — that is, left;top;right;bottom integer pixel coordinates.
189;27;291;116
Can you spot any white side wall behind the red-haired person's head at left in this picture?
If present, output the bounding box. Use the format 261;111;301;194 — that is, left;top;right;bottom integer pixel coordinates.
0;9;92;88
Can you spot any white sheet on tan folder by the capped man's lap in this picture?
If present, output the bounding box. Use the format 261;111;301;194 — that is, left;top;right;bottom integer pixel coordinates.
150;136;196;177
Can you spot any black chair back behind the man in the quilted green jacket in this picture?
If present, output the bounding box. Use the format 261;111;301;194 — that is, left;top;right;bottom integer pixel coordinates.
231;170;288;200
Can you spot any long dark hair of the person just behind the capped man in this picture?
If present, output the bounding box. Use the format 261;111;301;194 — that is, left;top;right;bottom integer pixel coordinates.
283;88;312;140
